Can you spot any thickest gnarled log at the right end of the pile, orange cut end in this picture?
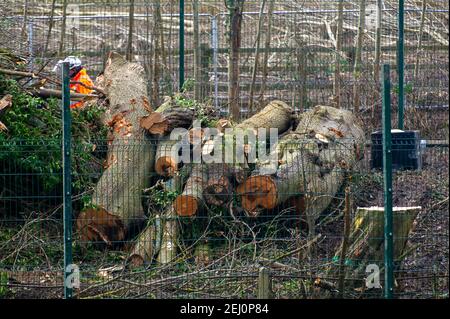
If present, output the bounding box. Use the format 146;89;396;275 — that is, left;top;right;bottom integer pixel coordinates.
237;106;364;234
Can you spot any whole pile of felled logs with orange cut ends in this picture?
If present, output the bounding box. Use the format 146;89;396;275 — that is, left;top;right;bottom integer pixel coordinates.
76;53;370;265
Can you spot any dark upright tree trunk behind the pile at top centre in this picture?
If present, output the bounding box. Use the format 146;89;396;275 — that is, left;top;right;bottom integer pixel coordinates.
227;0;244;121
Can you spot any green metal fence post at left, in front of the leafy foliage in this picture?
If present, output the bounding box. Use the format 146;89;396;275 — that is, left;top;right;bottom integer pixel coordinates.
62;62;73;299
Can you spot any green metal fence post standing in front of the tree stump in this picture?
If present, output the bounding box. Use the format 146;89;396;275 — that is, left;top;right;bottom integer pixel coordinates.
382;64;394;299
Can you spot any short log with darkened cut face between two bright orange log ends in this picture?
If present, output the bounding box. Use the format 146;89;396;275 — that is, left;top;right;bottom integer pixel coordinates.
203;163;233;206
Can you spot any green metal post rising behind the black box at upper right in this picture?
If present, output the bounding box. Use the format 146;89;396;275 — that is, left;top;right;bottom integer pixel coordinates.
397;0;405;130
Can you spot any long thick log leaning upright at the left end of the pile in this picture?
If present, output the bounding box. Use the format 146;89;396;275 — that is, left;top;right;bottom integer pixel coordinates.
76;53;155;245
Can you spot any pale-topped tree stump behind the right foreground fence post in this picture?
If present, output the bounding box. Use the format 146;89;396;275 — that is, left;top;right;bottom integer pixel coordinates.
326;206;422;297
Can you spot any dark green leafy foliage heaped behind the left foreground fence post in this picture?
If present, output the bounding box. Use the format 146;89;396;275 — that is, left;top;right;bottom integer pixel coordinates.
0;76;106;192
